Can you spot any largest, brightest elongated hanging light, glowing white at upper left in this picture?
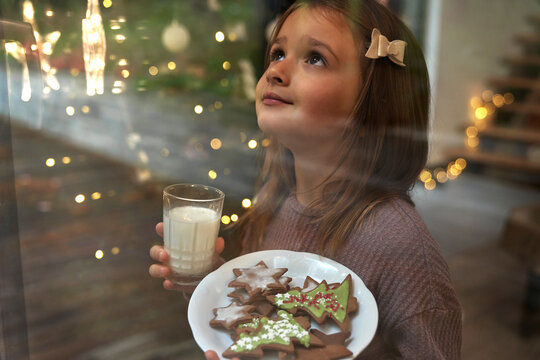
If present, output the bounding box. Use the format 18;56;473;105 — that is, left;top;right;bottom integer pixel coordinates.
82;0;107;96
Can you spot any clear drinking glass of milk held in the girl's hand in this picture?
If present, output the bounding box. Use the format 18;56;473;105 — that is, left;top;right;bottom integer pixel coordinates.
163;184;225;285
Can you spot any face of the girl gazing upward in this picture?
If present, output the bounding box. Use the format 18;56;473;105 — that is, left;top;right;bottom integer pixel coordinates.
256;7;361;152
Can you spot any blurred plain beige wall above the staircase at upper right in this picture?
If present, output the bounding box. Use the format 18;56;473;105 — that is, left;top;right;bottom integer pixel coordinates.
428;0;540;165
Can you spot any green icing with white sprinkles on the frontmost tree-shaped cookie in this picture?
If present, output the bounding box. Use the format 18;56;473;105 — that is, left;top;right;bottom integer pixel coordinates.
230;310;309;353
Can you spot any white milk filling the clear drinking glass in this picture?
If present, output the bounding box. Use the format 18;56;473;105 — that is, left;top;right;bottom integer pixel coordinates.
163;206;219;275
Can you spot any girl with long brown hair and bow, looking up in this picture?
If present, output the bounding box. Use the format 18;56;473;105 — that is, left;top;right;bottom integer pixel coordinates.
150;0;461;359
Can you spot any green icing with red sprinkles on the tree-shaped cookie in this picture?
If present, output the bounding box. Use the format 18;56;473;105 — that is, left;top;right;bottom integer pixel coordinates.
274;279;349;322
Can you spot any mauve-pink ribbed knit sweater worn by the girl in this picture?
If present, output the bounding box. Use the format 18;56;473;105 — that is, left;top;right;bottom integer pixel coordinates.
244;195;461;360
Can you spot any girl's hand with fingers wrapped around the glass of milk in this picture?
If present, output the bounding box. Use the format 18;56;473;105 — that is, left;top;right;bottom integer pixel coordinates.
148;222;225;294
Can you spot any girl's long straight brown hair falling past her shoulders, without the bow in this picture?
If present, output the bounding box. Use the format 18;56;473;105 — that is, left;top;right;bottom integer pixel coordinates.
238;0;430;255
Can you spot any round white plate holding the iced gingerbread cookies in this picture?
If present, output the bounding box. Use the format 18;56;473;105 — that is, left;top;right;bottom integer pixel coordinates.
188;250;379;358
